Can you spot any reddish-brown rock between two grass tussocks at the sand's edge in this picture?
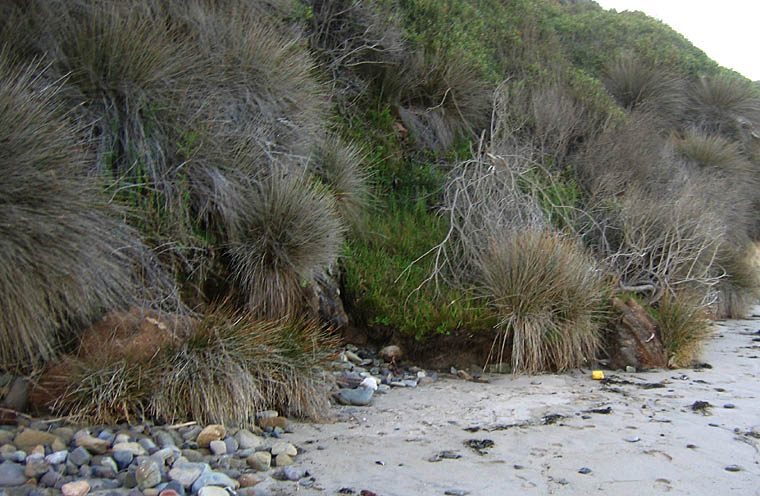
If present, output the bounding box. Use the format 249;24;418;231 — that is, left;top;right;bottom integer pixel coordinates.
609;298;668;368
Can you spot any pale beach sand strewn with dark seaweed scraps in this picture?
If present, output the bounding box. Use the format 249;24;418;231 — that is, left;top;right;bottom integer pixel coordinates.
278;308;760;496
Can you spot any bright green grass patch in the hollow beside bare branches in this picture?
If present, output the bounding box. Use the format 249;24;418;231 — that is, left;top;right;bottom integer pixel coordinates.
343;203;496;340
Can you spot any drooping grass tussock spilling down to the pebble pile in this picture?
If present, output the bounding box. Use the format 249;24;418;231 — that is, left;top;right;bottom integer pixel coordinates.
152;309;334;425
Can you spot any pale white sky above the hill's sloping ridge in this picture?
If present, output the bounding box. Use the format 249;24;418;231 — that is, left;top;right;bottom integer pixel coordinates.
596;0;760;81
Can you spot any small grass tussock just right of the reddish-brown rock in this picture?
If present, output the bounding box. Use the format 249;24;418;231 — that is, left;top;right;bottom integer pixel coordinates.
656;292;711;368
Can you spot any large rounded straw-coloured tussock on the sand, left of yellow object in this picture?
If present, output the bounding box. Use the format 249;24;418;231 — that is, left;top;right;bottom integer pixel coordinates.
478;230;609;373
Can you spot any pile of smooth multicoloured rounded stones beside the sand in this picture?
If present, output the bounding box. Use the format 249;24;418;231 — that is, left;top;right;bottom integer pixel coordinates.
0;412;314;496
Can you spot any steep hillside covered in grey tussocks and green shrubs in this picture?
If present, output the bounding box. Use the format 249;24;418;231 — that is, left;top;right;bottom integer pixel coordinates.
0;0;760;419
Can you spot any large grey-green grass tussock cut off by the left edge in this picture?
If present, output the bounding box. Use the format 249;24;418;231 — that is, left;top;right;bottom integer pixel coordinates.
0;56;145;369
